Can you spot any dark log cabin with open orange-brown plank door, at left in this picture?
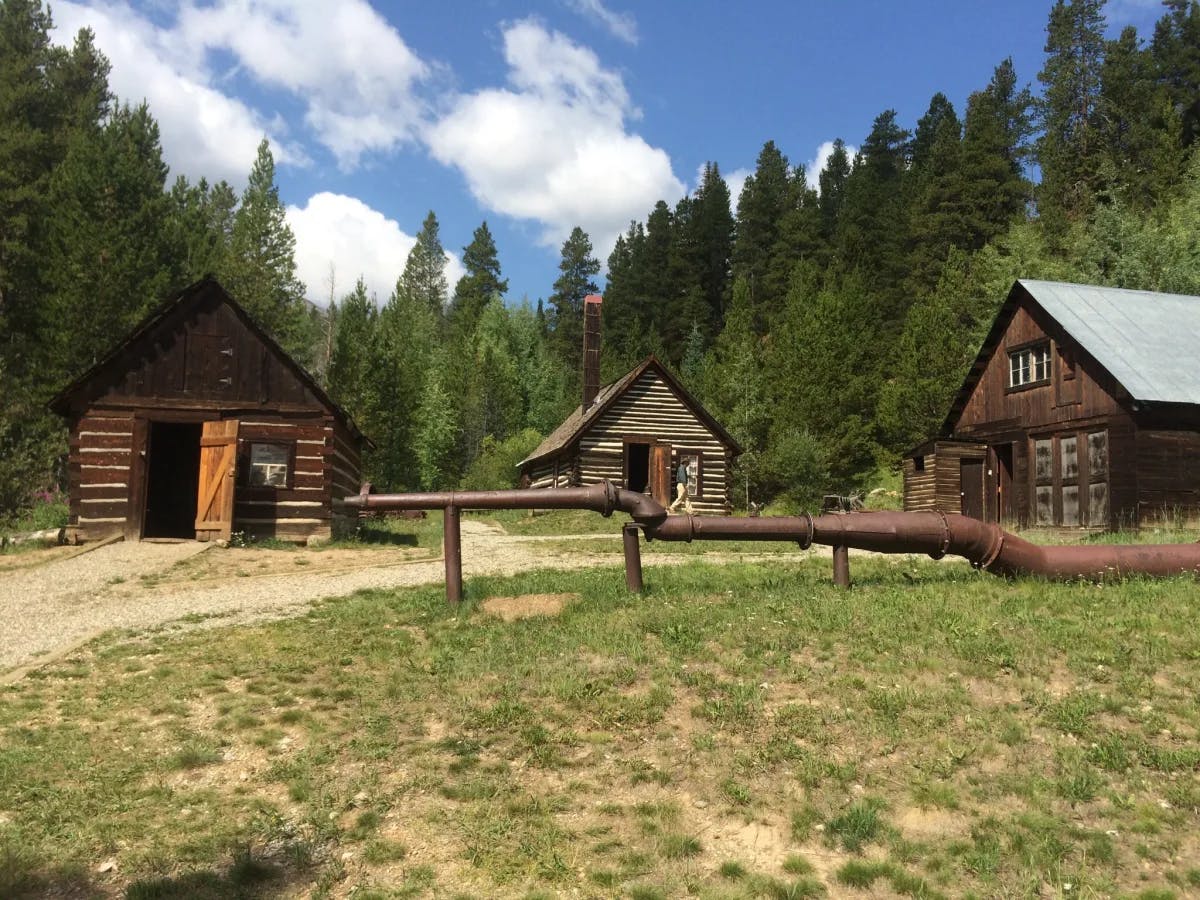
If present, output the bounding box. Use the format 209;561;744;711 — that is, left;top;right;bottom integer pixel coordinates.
50;278;365;541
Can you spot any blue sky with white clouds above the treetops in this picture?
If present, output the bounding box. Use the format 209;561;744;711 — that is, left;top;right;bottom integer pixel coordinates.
52;0;1162;302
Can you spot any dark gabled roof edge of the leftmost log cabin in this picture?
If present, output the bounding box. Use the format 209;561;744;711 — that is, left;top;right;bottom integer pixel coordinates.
48;276;370;443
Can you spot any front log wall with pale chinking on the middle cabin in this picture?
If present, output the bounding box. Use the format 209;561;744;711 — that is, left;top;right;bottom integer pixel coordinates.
572;370;730;515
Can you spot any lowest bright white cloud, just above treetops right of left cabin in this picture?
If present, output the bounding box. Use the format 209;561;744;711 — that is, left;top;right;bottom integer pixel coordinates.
287;191;463;306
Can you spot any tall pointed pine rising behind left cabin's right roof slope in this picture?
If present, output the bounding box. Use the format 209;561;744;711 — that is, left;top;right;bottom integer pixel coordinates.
221;138;317;365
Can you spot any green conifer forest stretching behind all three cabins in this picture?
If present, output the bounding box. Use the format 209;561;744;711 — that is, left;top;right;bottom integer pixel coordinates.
0;0;1200;514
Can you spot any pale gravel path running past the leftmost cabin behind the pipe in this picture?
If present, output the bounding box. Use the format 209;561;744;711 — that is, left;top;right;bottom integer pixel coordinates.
0;520;648;683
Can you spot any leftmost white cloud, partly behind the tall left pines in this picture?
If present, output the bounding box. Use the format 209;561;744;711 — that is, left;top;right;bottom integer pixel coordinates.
54;0;306;184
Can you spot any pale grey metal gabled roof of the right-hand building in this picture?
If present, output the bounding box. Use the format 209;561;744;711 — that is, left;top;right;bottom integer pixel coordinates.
943;278;1200;431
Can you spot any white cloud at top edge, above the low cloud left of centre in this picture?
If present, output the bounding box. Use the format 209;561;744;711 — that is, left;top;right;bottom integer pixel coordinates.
176;0;431;169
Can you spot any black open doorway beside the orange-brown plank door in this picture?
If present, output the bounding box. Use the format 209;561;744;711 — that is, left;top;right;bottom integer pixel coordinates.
142;422;200;538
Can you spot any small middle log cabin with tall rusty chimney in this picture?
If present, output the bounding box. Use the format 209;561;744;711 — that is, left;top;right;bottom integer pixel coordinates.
517;294;742;515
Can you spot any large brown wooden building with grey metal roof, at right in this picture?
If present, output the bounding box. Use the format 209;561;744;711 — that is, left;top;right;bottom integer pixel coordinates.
904;281;1200;530
